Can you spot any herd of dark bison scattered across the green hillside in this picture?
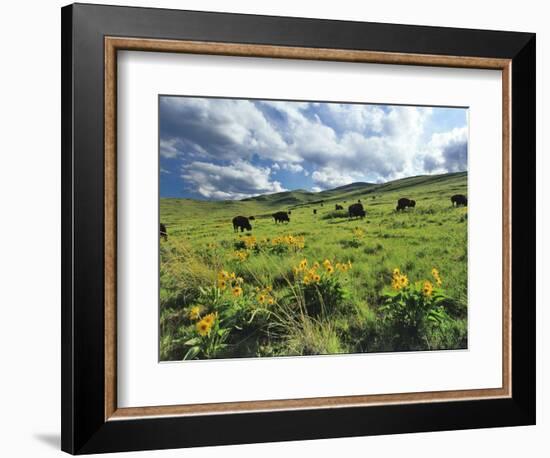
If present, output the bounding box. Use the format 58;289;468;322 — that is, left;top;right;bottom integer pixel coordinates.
160;194;468;240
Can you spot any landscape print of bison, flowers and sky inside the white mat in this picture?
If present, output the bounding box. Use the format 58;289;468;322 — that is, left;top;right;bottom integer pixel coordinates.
159;95;468;361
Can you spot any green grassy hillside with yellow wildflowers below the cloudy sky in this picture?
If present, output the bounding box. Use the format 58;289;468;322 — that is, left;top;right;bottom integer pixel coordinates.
160;173;467;360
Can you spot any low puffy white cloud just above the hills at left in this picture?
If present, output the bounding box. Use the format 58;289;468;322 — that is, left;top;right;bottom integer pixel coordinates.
181;160;286;200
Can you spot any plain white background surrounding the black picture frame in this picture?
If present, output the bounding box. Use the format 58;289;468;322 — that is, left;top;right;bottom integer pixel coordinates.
0;0;550;458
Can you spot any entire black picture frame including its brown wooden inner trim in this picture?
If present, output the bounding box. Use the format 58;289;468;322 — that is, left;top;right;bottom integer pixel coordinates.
62;5;535;453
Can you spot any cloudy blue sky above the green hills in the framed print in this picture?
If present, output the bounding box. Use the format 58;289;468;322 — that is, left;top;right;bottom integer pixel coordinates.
160;96;468;200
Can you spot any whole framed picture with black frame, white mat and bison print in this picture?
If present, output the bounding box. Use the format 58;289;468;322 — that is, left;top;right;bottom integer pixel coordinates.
62;4;535;454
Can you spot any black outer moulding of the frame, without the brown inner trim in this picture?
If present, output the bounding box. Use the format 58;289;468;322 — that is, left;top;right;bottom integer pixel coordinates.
61;4;536;454
